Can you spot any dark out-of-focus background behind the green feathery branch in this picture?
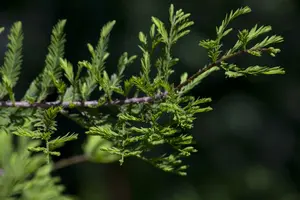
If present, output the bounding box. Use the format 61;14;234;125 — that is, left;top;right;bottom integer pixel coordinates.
0;0;300;200
